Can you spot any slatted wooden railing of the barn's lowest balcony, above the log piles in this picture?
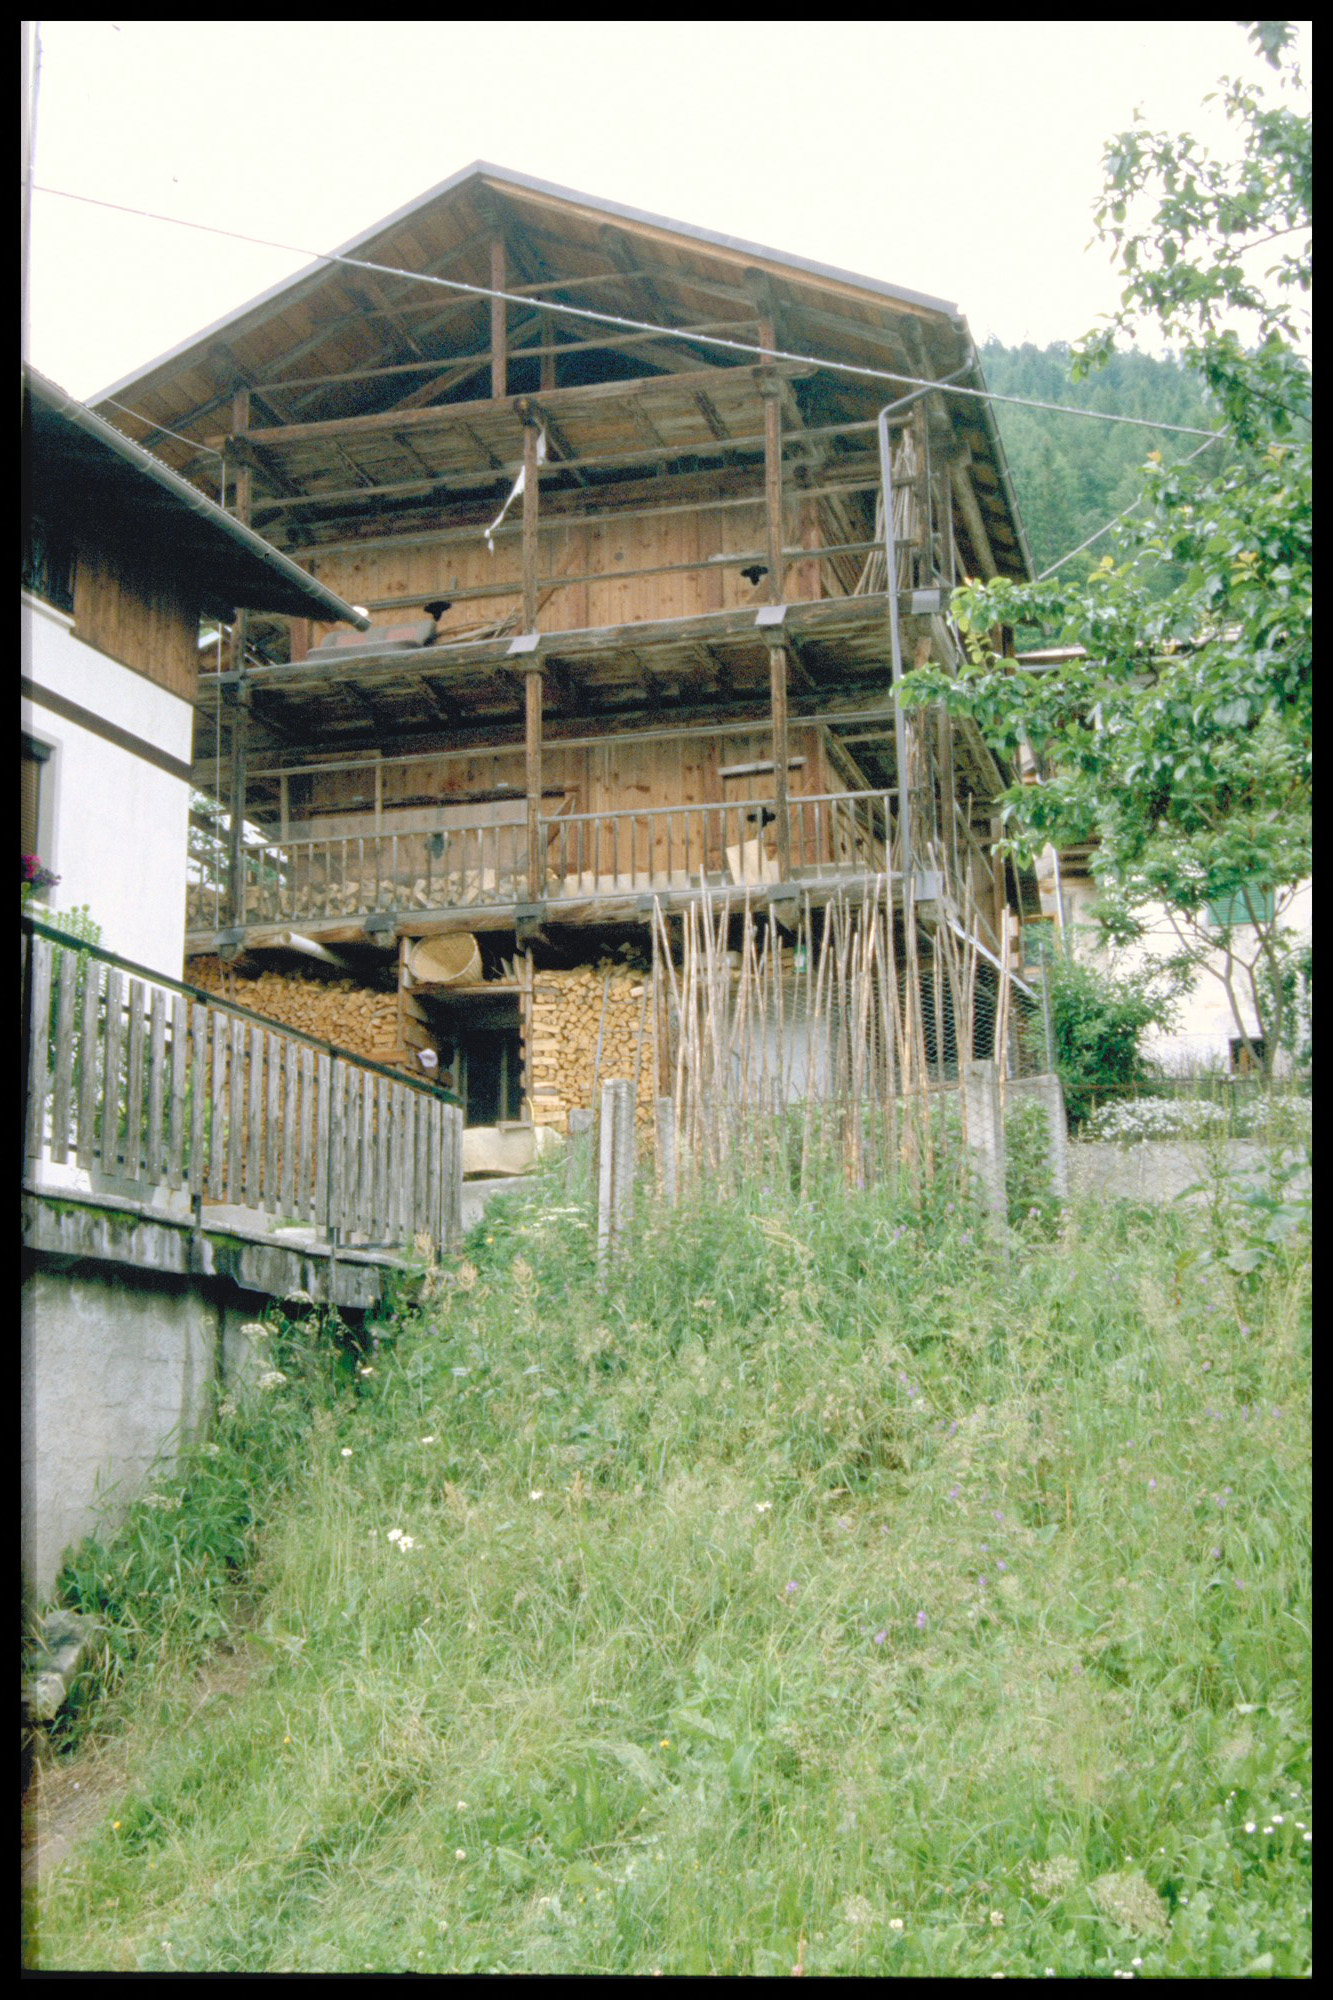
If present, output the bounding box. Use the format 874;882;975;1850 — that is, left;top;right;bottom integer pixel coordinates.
186;790;897;950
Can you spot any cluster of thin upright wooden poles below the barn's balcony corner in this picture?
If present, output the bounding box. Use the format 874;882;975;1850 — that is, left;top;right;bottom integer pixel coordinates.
640;876;1049;1214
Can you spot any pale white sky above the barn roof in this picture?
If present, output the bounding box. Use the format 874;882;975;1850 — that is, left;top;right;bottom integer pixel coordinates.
20;20;1309;398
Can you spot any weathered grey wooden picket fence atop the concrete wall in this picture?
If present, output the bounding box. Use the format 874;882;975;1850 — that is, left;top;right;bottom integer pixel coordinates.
22;920;462;1250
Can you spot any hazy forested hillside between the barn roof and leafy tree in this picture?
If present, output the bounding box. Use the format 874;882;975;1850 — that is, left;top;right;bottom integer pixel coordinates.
981;340;1223;576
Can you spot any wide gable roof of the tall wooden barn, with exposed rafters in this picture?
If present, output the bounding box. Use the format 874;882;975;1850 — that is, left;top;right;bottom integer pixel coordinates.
94;160;1031;576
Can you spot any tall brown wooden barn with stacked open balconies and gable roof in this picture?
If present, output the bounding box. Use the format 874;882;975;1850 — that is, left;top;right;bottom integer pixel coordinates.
100;164;1037;1124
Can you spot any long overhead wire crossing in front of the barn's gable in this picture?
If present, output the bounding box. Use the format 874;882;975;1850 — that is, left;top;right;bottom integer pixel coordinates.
34;186;1221;442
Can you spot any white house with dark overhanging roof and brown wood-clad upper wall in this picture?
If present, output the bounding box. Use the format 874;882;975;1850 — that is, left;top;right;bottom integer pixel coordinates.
20;368;368;978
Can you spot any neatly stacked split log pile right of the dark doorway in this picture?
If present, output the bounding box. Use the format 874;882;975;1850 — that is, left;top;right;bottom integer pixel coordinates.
526;960;656;1130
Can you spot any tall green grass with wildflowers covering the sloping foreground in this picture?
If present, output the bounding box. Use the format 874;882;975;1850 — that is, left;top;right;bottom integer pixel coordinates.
34;1152;1311;1976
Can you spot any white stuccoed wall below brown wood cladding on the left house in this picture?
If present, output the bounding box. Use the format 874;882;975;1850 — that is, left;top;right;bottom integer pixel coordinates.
22;594;194;978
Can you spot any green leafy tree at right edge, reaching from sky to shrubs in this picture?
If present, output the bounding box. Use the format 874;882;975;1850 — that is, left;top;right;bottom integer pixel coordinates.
907;22;1313;1074
